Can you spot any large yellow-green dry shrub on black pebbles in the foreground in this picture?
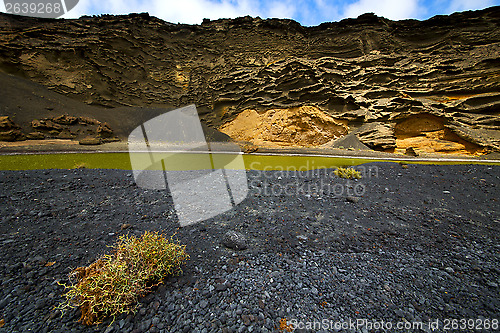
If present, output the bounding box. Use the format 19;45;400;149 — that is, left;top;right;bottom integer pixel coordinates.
59;232;189;325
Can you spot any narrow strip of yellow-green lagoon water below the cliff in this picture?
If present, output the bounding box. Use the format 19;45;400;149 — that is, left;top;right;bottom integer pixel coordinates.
0;152;500;171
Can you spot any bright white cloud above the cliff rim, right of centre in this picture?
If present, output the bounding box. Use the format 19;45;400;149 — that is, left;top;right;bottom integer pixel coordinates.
343;0;423;20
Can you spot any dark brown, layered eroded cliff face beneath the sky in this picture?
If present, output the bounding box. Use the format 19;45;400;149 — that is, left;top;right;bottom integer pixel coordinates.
0;7;500;151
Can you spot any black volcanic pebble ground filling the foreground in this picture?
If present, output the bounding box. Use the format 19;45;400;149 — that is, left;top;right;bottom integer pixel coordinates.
0;163;500;333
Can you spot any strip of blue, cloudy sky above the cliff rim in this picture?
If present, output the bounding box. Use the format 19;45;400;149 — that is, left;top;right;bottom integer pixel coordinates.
0;0;500;26
